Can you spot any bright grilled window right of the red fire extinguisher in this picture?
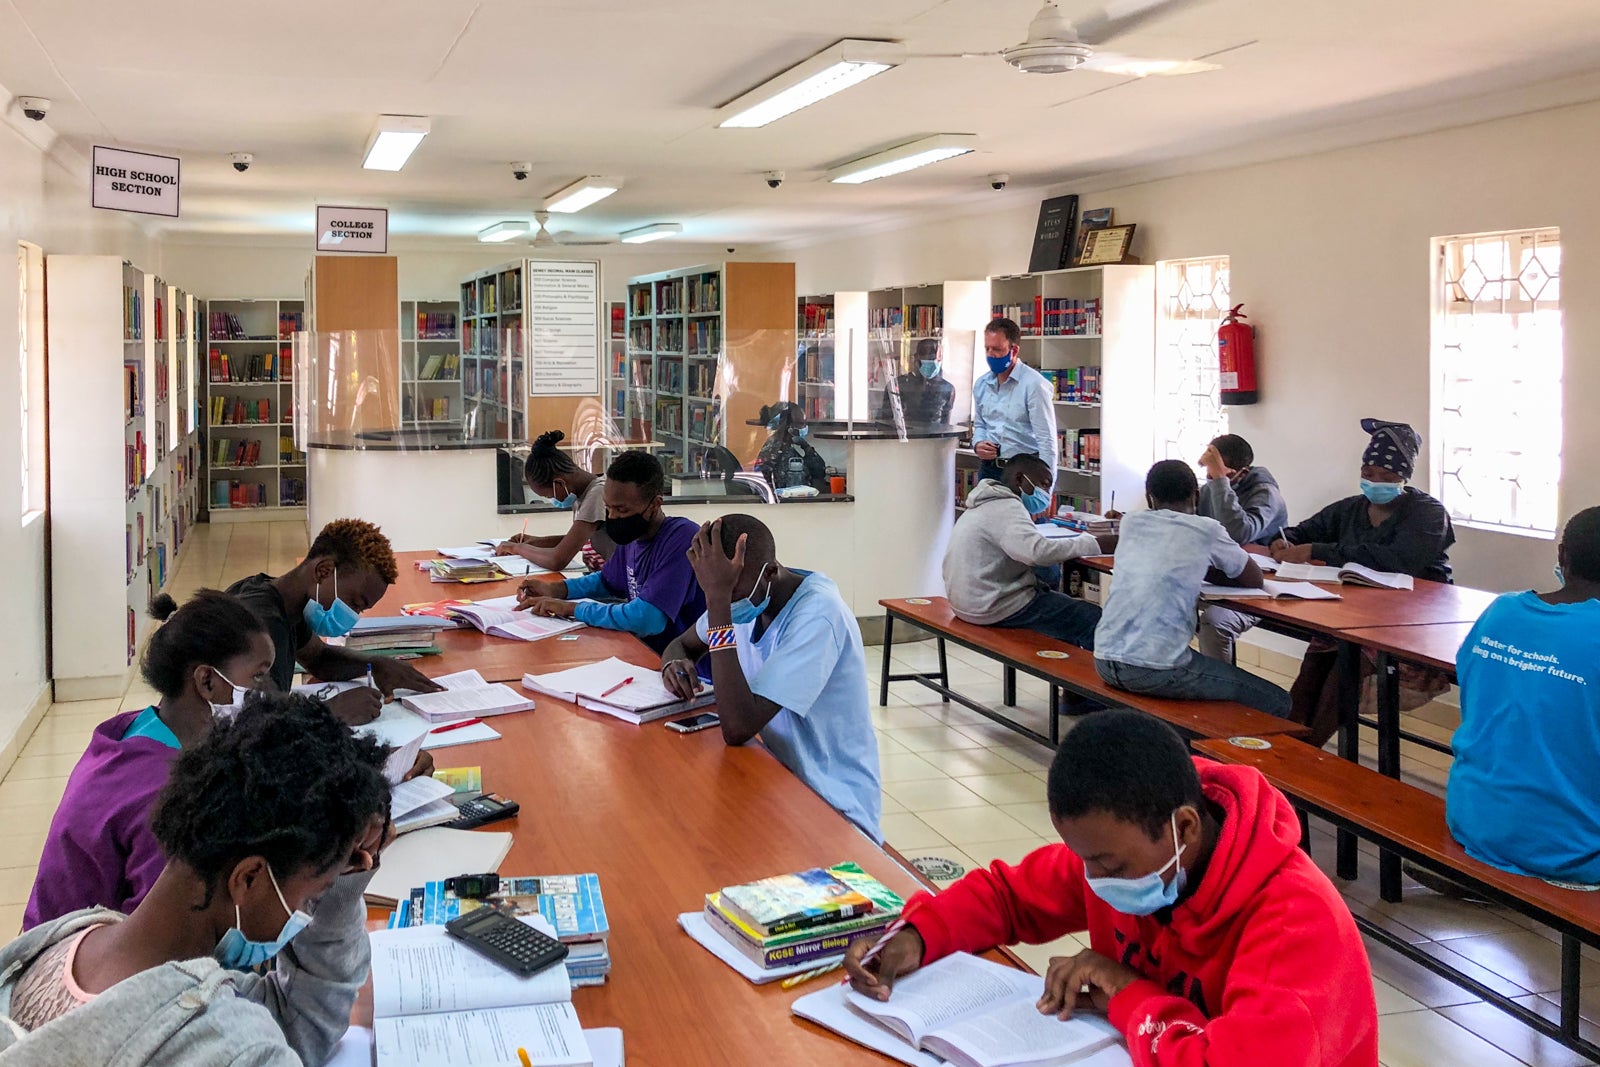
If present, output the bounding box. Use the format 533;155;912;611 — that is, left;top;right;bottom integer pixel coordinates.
1429;229;1563;537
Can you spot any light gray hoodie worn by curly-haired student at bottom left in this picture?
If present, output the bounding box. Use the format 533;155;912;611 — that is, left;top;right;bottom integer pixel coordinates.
0;873;373;1067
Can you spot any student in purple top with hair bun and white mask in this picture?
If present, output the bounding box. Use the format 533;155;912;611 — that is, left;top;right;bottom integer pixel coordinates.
22;589;272;929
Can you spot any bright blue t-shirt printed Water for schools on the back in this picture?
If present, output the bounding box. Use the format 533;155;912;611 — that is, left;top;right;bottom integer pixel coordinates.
1445;592;1600;885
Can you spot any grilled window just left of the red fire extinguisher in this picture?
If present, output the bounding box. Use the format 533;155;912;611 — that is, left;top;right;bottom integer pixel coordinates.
1155;256;1230;462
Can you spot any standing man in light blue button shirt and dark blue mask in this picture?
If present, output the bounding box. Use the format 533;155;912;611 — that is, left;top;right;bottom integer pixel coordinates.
973;318;1061;480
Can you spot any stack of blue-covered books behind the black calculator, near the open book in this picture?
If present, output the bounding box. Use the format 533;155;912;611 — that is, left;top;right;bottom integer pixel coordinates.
389;875;611;989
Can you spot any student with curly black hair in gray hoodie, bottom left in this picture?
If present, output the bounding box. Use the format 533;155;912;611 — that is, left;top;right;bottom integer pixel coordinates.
0;693;389;1067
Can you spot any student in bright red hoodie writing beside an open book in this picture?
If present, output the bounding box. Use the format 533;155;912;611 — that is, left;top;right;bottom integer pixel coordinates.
845;710;1378;1067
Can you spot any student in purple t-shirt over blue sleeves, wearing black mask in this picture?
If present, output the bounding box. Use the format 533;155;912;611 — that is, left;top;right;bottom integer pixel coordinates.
517;451;706;653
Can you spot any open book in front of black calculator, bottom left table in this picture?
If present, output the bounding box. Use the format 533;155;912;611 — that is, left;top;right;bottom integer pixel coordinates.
371;915;594;1067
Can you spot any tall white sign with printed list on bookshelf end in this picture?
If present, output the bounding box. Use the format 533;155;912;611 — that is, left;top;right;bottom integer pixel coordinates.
525;259;602;397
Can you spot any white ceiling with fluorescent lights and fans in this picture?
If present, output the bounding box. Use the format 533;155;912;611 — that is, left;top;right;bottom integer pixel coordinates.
9;0;1600;243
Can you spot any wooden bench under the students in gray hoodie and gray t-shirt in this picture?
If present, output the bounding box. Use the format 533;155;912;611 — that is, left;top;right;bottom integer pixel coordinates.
878;597;1306;749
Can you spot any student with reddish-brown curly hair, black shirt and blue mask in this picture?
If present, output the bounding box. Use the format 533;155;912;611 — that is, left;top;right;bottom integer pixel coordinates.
227;518;438;726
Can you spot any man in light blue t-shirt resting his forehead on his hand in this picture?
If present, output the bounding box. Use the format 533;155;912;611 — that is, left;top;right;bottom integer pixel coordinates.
661;515;883;841
